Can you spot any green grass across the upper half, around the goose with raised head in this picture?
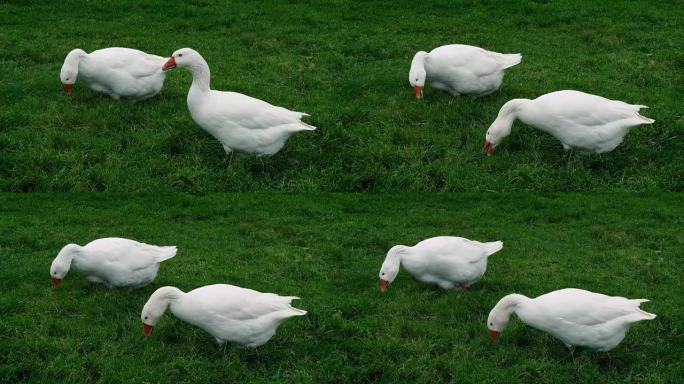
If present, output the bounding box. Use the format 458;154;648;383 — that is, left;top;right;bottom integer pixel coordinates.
0;0;684;192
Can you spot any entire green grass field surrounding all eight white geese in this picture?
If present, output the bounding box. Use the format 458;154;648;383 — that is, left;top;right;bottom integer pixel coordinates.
0;0;684;384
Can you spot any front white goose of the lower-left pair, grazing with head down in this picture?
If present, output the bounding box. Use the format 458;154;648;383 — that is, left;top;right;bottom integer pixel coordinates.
140;284;306;347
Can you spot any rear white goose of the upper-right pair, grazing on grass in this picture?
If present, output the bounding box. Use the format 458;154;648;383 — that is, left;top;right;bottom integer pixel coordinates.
409;44;522;99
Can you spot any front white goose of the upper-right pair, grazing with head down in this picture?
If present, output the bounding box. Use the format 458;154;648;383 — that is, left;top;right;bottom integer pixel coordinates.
484;91;655;156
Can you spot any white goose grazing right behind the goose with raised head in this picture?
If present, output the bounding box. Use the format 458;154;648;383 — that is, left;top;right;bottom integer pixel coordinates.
59;47;166;100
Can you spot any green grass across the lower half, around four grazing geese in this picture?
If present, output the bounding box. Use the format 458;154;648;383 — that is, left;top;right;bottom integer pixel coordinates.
0;194;684;383
